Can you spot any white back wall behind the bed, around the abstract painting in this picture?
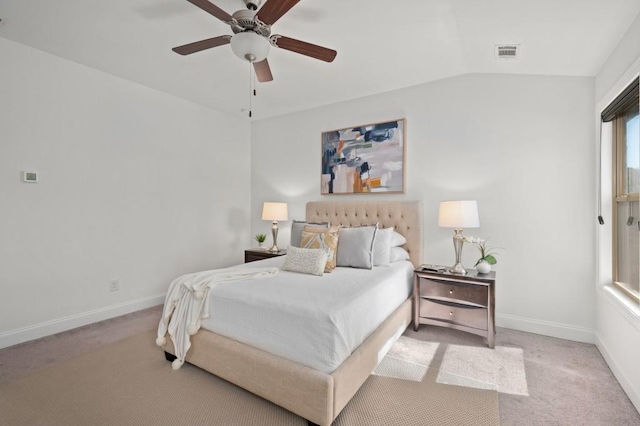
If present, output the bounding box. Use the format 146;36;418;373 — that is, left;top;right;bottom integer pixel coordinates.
251;71;595;341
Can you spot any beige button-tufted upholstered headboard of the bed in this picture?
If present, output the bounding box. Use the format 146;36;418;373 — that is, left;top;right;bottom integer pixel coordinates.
306;201;423;267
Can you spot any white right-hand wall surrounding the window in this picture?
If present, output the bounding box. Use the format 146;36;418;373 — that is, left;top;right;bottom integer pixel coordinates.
594;16;640;410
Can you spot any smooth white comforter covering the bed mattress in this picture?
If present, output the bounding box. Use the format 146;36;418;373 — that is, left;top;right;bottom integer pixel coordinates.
202;257;413;373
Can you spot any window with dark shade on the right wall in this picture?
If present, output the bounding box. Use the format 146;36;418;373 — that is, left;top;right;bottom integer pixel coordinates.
602;79;640;302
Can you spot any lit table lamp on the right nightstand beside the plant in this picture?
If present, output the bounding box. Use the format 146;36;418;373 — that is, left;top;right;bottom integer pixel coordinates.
438;200;480;275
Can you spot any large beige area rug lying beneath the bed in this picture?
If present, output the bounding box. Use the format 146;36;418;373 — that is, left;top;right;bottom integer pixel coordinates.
0;333;499;426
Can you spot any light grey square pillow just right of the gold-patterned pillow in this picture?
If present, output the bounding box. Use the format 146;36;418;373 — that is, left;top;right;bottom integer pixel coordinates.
337;224;378;269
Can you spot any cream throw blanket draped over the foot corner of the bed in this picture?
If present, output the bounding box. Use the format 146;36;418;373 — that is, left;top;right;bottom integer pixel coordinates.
156;268;278;370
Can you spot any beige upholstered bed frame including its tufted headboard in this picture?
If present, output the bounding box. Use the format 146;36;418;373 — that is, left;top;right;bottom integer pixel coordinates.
163;201;423;426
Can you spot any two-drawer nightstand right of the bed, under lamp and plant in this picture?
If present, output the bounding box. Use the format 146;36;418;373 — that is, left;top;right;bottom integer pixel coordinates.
413;269;496;349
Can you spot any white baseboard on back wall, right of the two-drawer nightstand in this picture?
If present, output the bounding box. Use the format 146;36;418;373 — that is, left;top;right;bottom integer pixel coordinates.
496;314;595;343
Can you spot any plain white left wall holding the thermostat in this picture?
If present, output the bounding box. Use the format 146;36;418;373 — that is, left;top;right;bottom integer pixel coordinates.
0;38;251;347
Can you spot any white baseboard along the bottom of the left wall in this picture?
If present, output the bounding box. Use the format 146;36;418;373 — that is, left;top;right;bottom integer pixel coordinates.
0;294;165;349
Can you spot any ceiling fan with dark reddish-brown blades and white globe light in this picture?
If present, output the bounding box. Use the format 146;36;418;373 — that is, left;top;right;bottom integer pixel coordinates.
172;0;338;82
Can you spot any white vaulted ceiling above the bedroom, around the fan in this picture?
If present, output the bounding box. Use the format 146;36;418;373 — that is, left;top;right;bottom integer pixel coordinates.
0;0;640;119
